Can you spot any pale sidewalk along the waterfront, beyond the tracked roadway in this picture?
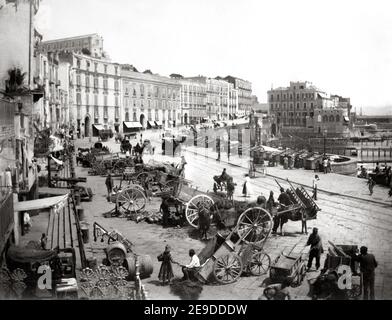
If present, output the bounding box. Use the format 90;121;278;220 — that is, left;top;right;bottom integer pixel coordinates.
184;146;392;206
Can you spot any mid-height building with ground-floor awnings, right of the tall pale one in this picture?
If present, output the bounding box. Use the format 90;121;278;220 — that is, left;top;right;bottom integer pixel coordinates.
121;65;181;128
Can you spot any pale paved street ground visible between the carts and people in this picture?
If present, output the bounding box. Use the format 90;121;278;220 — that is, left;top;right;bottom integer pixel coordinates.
76;131;392;299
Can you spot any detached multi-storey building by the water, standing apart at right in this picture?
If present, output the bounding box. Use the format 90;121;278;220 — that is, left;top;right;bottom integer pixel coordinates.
268;82;351;136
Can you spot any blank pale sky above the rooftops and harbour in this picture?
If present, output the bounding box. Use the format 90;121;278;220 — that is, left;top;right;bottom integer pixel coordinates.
36;0;392;114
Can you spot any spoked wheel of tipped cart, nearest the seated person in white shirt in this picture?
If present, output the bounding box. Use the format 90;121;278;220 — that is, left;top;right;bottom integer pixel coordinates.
213;253;243;284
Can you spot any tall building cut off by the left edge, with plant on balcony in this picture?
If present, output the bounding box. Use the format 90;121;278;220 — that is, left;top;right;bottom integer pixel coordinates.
0;0;44;260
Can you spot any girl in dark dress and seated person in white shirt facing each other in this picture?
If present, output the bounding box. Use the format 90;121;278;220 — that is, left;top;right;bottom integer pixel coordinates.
157;245;200;285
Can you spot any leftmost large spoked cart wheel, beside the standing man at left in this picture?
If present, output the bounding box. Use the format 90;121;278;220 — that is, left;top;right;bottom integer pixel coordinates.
116;186;147;213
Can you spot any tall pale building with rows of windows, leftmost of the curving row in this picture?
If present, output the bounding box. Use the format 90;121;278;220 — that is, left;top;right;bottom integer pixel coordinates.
59;52;121;137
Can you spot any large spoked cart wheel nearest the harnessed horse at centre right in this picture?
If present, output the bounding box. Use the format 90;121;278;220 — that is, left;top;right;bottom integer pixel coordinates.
236;207;272;243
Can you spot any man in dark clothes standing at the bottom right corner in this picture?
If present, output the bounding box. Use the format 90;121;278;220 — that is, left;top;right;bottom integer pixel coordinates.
358;247;378;300
